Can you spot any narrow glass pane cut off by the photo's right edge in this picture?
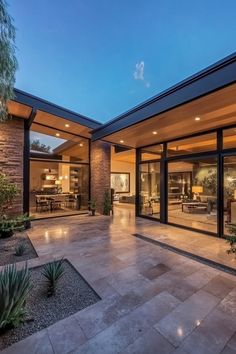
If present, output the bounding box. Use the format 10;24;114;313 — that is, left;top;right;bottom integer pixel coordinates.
224;156;236;235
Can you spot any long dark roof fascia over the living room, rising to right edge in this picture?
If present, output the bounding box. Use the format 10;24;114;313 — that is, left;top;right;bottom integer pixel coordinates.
92;52;236;141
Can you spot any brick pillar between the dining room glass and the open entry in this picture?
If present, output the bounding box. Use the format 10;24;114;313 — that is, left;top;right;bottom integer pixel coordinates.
90;141;111;213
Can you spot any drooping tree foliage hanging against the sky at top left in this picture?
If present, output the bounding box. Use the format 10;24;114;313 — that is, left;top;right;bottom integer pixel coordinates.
0;0;18;122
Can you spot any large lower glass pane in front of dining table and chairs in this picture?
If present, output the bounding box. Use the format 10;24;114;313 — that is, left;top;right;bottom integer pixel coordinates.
30;161;89;218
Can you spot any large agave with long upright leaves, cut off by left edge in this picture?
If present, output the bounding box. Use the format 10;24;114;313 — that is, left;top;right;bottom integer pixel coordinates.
0;264;31;330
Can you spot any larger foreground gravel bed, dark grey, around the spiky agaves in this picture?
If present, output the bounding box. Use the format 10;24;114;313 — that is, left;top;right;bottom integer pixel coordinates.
0;260;100;350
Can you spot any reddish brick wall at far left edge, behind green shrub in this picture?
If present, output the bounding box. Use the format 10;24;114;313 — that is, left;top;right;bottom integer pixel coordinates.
0;119;24;214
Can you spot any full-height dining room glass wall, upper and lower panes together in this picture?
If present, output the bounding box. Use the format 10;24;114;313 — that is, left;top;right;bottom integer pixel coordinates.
30;124;89;218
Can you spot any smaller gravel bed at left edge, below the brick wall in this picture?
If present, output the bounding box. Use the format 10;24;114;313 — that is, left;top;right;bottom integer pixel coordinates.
0;232;38;266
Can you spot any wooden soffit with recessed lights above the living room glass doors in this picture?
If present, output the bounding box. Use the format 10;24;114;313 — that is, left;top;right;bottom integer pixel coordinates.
105;84;236;147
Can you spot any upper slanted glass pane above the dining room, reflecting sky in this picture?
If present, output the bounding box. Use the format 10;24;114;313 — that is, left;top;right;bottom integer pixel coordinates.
30;124;89;162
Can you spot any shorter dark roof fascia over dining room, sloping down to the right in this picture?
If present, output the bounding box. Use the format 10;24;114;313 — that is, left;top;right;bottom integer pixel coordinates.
13;88;102;129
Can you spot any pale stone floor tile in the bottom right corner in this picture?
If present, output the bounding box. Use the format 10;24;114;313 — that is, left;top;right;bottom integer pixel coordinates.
181;308;236;354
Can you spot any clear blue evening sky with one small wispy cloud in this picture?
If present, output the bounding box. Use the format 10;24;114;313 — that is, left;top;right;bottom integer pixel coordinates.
8;0;236;122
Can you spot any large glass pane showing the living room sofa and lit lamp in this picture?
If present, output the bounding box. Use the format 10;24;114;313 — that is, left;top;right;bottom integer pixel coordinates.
168;158;217;233
